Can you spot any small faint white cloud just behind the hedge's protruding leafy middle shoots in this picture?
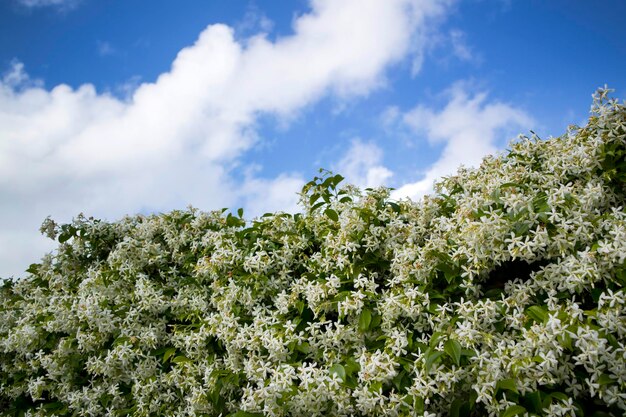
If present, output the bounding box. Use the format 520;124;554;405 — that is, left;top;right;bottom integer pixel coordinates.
333;139;393;187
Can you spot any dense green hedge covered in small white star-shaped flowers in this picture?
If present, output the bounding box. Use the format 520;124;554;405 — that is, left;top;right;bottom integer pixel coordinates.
0;90;626;417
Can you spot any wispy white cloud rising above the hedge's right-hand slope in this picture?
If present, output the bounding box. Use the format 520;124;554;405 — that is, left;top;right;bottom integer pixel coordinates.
392;84;533;199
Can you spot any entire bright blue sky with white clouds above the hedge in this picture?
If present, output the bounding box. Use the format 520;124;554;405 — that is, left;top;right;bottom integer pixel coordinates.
0;0;626;277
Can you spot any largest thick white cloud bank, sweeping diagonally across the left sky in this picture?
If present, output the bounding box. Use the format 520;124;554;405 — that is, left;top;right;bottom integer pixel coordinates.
0;0;449;276
